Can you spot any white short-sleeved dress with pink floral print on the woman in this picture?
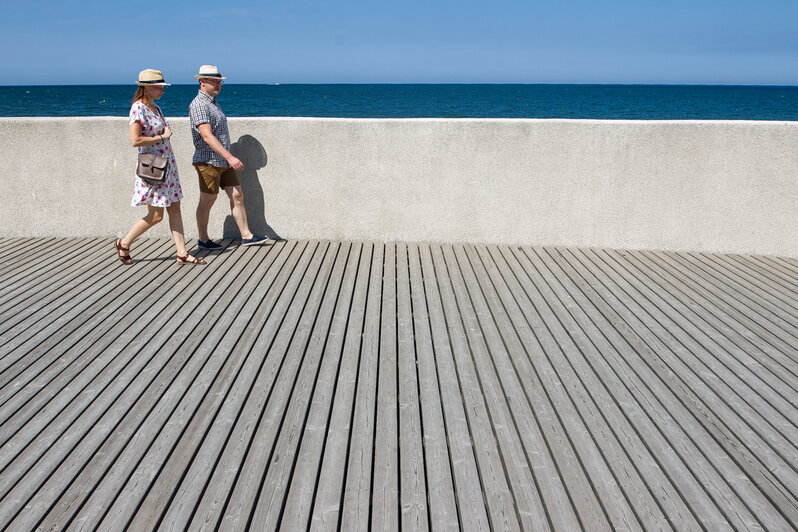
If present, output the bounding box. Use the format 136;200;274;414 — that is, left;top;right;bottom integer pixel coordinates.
130;100;183;207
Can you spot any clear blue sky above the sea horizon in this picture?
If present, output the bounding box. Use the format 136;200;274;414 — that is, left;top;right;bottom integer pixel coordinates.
0;0;798;85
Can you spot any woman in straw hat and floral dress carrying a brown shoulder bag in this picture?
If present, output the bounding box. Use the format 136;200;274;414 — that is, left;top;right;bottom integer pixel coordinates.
116;69;205;264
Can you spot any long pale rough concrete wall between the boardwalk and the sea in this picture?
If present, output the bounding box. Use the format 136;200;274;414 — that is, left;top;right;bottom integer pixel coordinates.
0;118;798;257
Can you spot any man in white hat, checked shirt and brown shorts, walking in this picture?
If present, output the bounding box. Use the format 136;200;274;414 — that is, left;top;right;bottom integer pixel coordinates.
188;65;269;250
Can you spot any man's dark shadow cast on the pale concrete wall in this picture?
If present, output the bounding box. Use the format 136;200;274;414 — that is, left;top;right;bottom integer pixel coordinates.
224;135;282;240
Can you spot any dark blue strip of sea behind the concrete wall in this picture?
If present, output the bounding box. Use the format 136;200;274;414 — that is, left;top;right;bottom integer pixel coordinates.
0;83;798;121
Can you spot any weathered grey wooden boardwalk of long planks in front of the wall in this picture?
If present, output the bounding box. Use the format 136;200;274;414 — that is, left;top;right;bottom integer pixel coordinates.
0;239;798;531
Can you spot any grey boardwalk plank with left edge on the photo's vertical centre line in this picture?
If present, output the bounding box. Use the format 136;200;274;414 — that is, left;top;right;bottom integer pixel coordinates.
396;244;428;532
